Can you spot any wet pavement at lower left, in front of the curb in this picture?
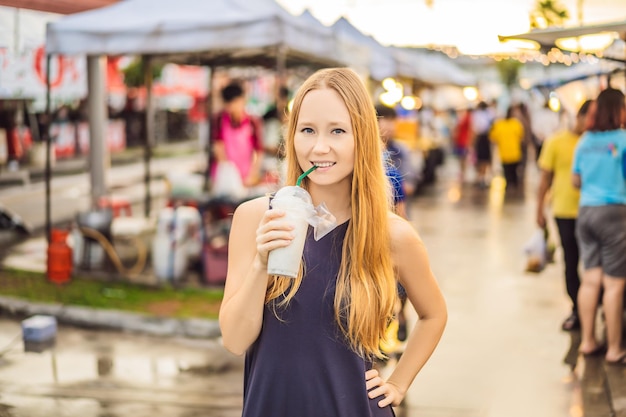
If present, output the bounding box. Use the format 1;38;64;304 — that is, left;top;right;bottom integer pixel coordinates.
0;320;242;417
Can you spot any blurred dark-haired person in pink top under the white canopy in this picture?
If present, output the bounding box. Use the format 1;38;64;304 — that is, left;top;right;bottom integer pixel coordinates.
210;82;263;187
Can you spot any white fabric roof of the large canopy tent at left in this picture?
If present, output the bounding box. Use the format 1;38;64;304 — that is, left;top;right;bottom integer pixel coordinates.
46;0;342;67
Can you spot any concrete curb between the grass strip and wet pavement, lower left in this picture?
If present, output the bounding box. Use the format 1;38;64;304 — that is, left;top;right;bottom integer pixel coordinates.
0;296;221;339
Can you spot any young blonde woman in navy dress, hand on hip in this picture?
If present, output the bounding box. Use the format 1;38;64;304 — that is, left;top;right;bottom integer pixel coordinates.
220;68;447;417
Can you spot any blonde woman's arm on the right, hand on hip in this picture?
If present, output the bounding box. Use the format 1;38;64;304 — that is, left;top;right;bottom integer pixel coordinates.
370;216;448;407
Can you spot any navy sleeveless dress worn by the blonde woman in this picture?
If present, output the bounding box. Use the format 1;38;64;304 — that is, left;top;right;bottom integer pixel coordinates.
243;222;394;417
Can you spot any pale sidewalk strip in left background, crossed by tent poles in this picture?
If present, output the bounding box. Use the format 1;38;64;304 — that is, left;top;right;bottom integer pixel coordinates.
0;141;206;237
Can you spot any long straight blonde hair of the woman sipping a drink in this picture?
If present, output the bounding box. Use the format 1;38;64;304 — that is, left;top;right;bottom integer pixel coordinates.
266;68;397;358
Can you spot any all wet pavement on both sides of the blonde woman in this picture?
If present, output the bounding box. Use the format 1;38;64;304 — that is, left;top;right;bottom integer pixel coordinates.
0;161;626;417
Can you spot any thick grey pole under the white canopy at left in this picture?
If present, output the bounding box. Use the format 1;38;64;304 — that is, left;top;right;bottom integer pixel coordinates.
87;56;110;208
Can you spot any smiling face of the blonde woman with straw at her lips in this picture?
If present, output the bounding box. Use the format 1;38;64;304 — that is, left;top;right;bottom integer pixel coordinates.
294;88;354;185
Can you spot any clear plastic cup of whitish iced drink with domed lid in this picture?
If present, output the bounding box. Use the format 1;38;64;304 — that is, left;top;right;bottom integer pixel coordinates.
267;186;315;278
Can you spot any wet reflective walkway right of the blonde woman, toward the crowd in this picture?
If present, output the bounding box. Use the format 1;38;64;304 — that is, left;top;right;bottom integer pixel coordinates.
392;166;626;417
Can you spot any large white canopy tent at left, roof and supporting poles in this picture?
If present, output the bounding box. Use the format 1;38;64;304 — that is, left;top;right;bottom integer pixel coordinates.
46;0;345;234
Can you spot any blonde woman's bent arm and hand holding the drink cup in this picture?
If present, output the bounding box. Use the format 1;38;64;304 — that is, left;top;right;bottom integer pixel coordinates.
219;197;293;355
